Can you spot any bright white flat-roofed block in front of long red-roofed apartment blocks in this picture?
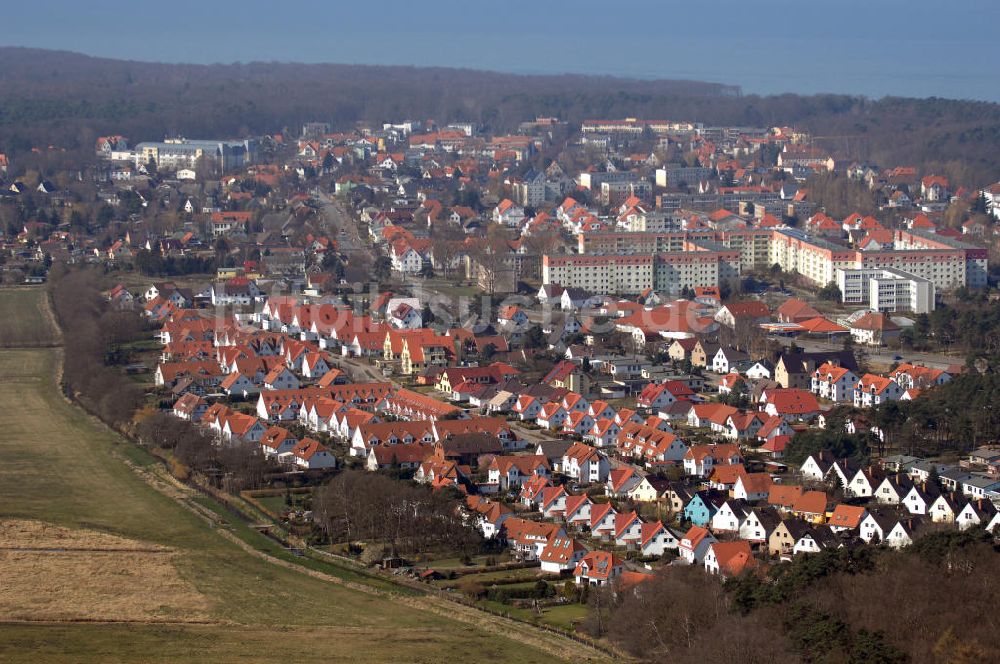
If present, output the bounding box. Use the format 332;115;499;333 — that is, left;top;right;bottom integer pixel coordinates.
836;267;934;314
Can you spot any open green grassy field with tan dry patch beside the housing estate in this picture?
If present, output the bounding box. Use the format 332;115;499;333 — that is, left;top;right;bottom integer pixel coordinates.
0;289;584;662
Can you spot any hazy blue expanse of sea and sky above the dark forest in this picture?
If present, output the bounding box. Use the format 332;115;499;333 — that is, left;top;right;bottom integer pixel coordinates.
0;0;1000;101
